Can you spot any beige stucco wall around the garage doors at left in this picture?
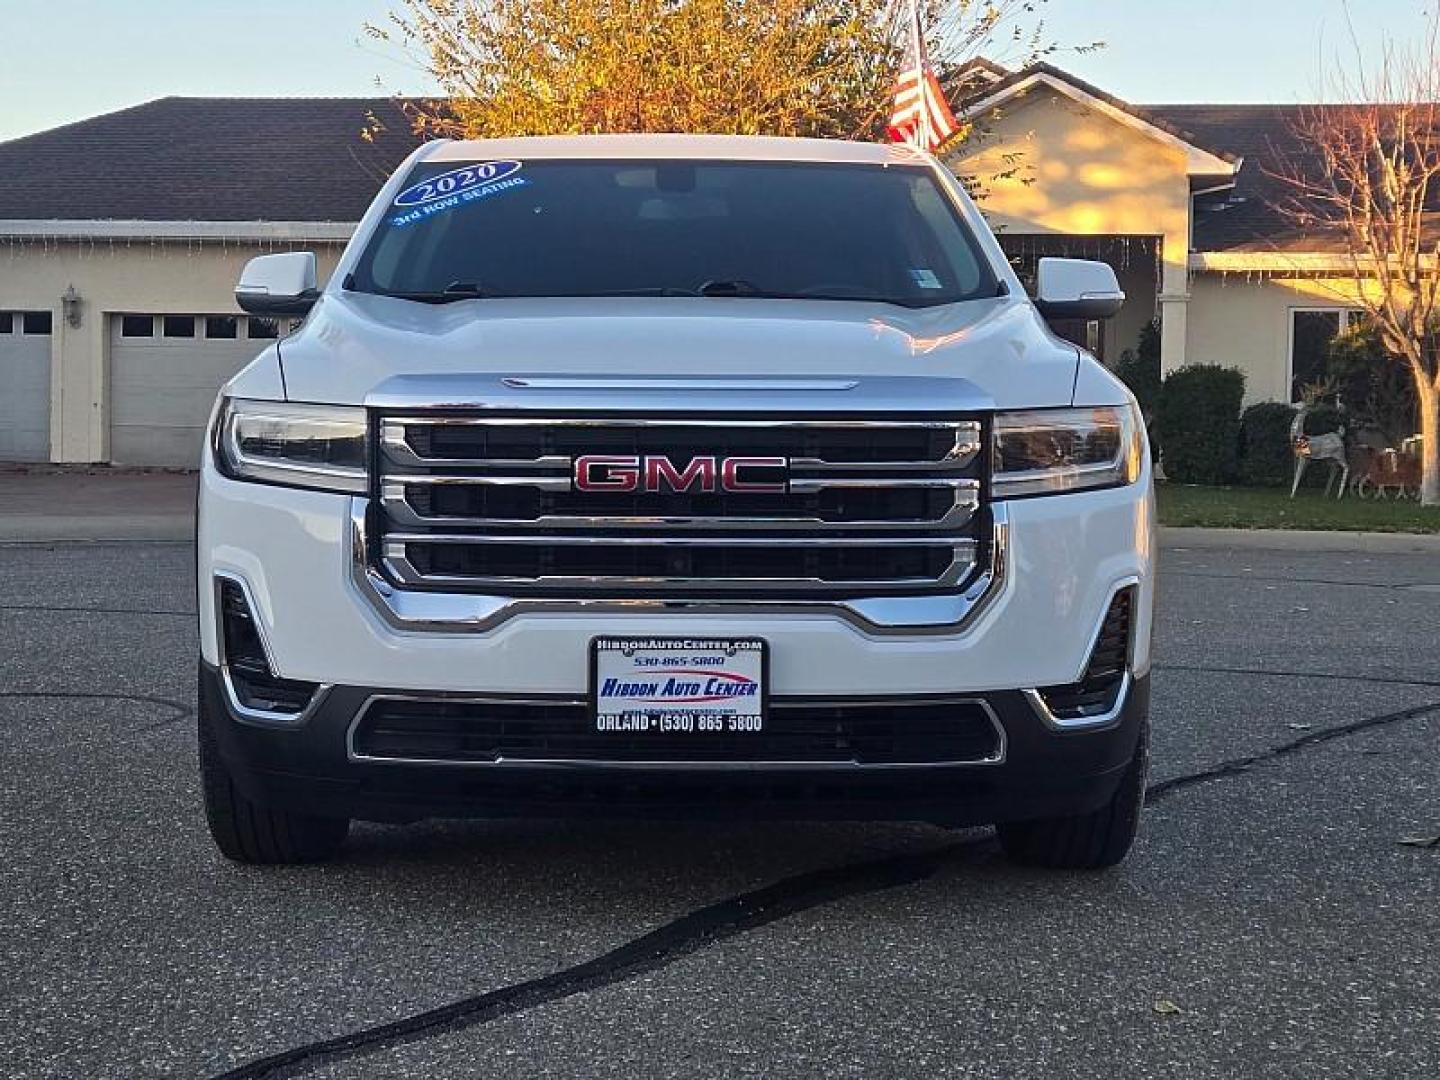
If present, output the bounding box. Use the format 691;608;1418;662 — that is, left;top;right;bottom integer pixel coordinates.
0;240;340;461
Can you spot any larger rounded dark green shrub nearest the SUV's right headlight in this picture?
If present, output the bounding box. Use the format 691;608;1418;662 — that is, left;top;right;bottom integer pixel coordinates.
1155;364;1246;484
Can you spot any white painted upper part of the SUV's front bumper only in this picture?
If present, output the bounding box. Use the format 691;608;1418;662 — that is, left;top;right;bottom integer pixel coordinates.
197;464;1155;697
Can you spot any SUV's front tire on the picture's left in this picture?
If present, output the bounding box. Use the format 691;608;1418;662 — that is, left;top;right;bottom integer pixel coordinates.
199;693;350;865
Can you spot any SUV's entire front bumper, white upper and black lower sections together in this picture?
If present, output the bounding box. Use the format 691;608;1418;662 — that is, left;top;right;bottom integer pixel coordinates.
197;452;1155;825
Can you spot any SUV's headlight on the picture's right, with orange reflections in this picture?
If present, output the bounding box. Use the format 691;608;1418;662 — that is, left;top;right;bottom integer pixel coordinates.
994;405;1145;498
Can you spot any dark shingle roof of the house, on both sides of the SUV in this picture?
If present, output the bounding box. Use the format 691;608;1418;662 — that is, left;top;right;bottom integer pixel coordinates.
0;87;1428;252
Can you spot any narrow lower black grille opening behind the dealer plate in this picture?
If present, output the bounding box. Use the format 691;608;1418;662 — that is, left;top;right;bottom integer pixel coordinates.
351;698;1002;765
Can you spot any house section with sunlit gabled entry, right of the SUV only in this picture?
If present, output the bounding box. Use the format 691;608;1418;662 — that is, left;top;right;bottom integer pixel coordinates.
948;62;1376;403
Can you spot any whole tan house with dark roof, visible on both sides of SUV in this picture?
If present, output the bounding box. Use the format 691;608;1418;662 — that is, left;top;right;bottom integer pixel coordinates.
0;74;1382;465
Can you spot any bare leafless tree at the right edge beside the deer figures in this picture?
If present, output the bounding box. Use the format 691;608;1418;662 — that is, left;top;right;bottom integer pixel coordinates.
1274;13;1440;505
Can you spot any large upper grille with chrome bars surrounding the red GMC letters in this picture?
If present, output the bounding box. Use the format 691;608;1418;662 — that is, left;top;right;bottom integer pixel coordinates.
372;413;988;598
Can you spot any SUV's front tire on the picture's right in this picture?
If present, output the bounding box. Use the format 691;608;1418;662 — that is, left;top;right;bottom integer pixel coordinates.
995;723;1151;870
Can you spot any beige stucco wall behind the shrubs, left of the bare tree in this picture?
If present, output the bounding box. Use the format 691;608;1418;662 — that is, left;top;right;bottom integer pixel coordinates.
1187;272;1358;405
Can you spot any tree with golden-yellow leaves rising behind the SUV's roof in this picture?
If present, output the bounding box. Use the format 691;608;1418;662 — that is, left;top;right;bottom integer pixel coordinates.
366;0;1071;138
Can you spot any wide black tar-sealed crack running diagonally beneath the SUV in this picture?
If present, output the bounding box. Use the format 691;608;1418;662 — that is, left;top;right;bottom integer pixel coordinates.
205;701;1440;1080
